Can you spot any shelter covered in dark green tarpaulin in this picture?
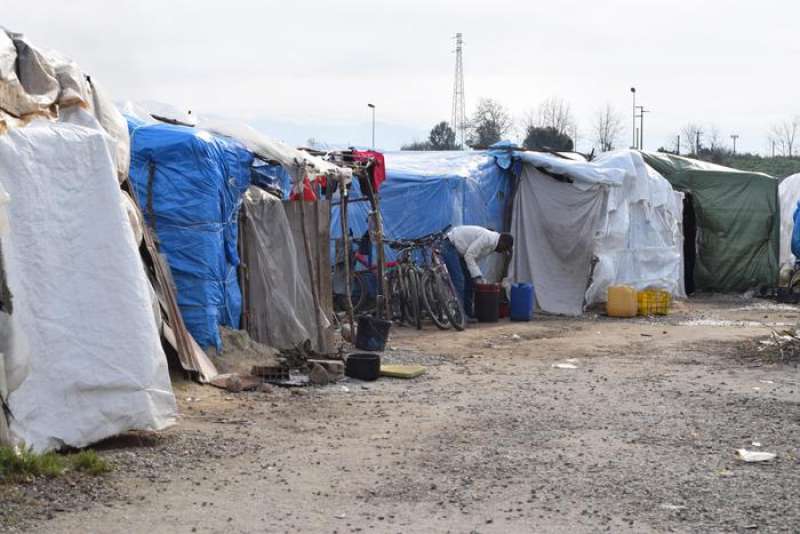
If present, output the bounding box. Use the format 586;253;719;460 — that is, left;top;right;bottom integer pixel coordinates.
642;152;781;292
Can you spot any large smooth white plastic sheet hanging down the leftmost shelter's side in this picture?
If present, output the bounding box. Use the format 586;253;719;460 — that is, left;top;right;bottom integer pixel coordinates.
0;121;176;451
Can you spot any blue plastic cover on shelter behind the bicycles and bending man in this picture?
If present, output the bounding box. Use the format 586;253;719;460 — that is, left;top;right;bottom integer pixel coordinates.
331;151;510;247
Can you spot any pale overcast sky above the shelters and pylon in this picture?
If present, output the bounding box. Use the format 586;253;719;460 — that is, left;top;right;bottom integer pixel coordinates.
0;0;800;152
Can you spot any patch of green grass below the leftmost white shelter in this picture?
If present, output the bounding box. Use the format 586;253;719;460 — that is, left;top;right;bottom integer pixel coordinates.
0;447;111;483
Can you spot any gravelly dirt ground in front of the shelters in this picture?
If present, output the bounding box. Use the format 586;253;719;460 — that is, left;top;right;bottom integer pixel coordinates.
0;297;800;534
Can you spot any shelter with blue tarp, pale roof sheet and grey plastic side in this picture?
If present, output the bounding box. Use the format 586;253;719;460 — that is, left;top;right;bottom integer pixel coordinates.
123;103;352;358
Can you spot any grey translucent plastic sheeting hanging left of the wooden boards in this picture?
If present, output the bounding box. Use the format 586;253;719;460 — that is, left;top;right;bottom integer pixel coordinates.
242;187;318;349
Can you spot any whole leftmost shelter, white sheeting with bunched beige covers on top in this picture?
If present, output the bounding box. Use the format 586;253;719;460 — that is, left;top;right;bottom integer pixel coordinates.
0;30;176;451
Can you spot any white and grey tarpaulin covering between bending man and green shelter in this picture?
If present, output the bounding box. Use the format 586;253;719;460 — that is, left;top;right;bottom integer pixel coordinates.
510;151;685;315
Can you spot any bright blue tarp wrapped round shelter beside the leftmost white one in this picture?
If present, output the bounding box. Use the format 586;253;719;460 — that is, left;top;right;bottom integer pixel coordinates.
128;121;253;349
